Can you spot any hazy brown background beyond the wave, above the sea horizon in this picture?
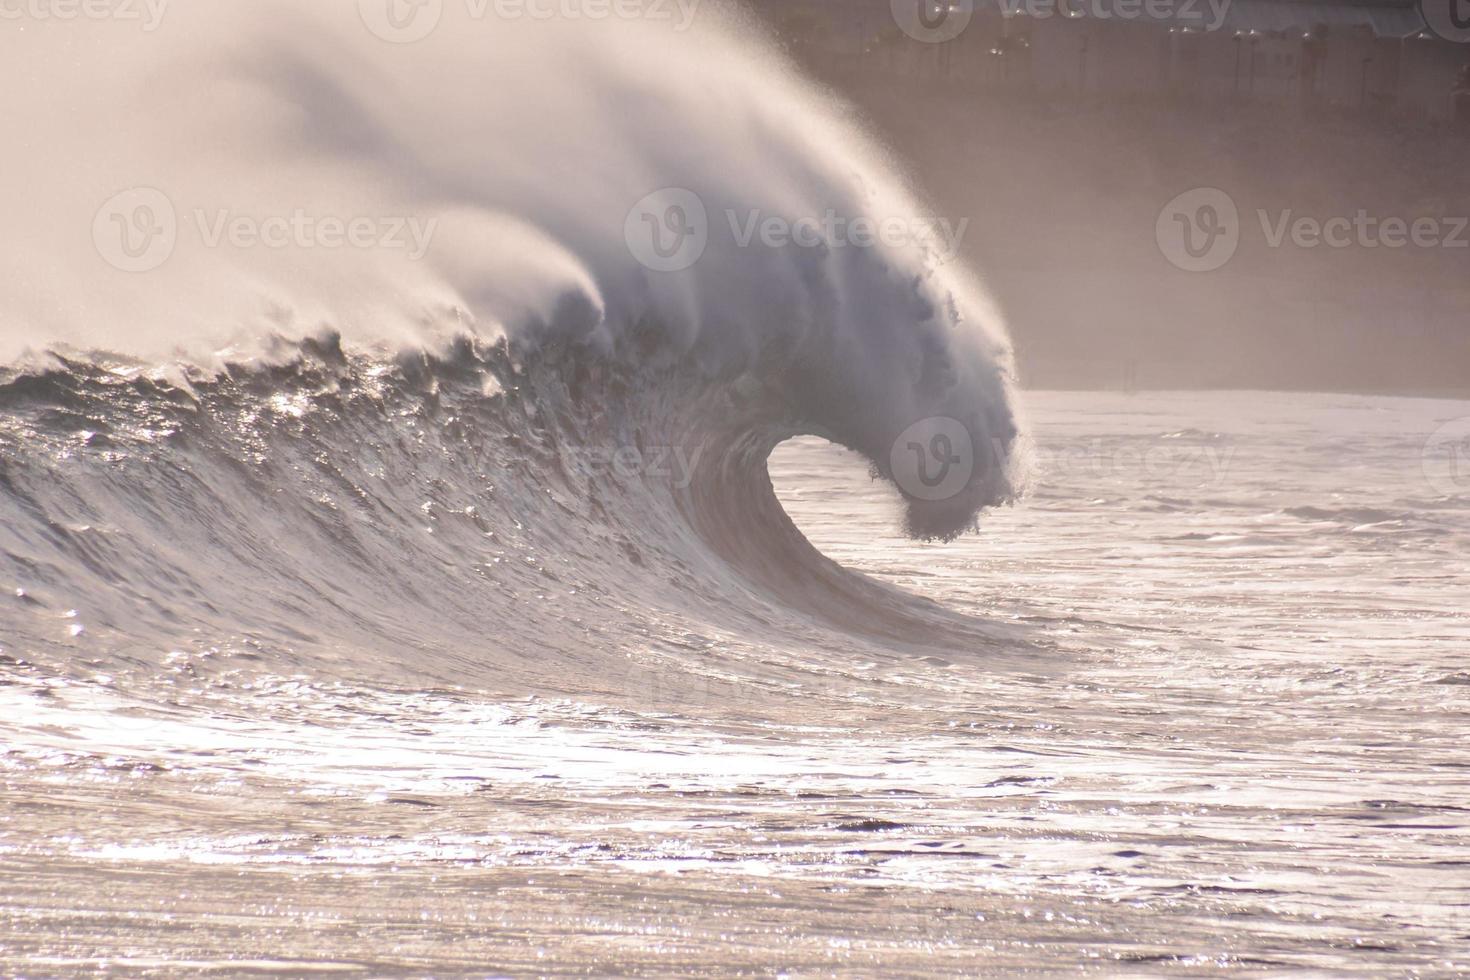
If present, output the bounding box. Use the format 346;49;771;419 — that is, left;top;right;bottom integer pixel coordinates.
754;0;1470;394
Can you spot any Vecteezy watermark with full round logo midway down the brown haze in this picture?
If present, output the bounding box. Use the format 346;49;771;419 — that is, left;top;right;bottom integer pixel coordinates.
1154;187;1470;272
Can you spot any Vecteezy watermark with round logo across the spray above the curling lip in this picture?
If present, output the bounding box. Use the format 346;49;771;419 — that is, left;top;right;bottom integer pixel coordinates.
623;188;970;272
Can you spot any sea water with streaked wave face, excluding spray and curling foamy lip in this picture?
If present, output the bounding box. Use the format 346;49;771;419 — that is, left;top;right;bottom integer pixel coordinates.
0;382;1470;977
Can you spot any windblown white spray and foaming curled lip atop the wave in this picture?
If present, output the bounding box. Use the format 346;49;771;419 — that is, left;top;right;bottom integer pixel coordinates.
0;0;1019;551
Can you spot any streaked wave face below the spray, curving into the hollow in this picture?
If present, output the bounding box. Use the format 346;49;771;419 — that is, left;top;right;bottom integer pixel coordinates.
0;334;1014;696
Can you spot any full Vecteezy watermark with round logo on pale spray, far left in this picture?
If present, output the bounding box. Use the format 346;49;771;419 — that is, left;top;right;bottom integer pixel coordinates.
93;187;438;272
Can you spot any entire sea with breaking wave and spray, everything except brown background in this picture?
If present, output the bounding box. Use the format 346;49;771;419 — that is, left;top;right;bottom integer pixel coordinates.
0;0;1470;976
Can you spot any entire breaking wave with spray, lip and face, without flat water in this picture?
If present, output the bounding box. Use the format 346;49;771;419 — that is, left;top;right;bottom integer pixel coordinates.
0;3;1022;688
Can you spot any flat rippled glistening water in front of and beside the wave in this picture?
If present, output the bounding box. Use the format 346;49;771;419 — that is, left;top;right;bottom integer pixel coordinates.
0;392;1470;976
